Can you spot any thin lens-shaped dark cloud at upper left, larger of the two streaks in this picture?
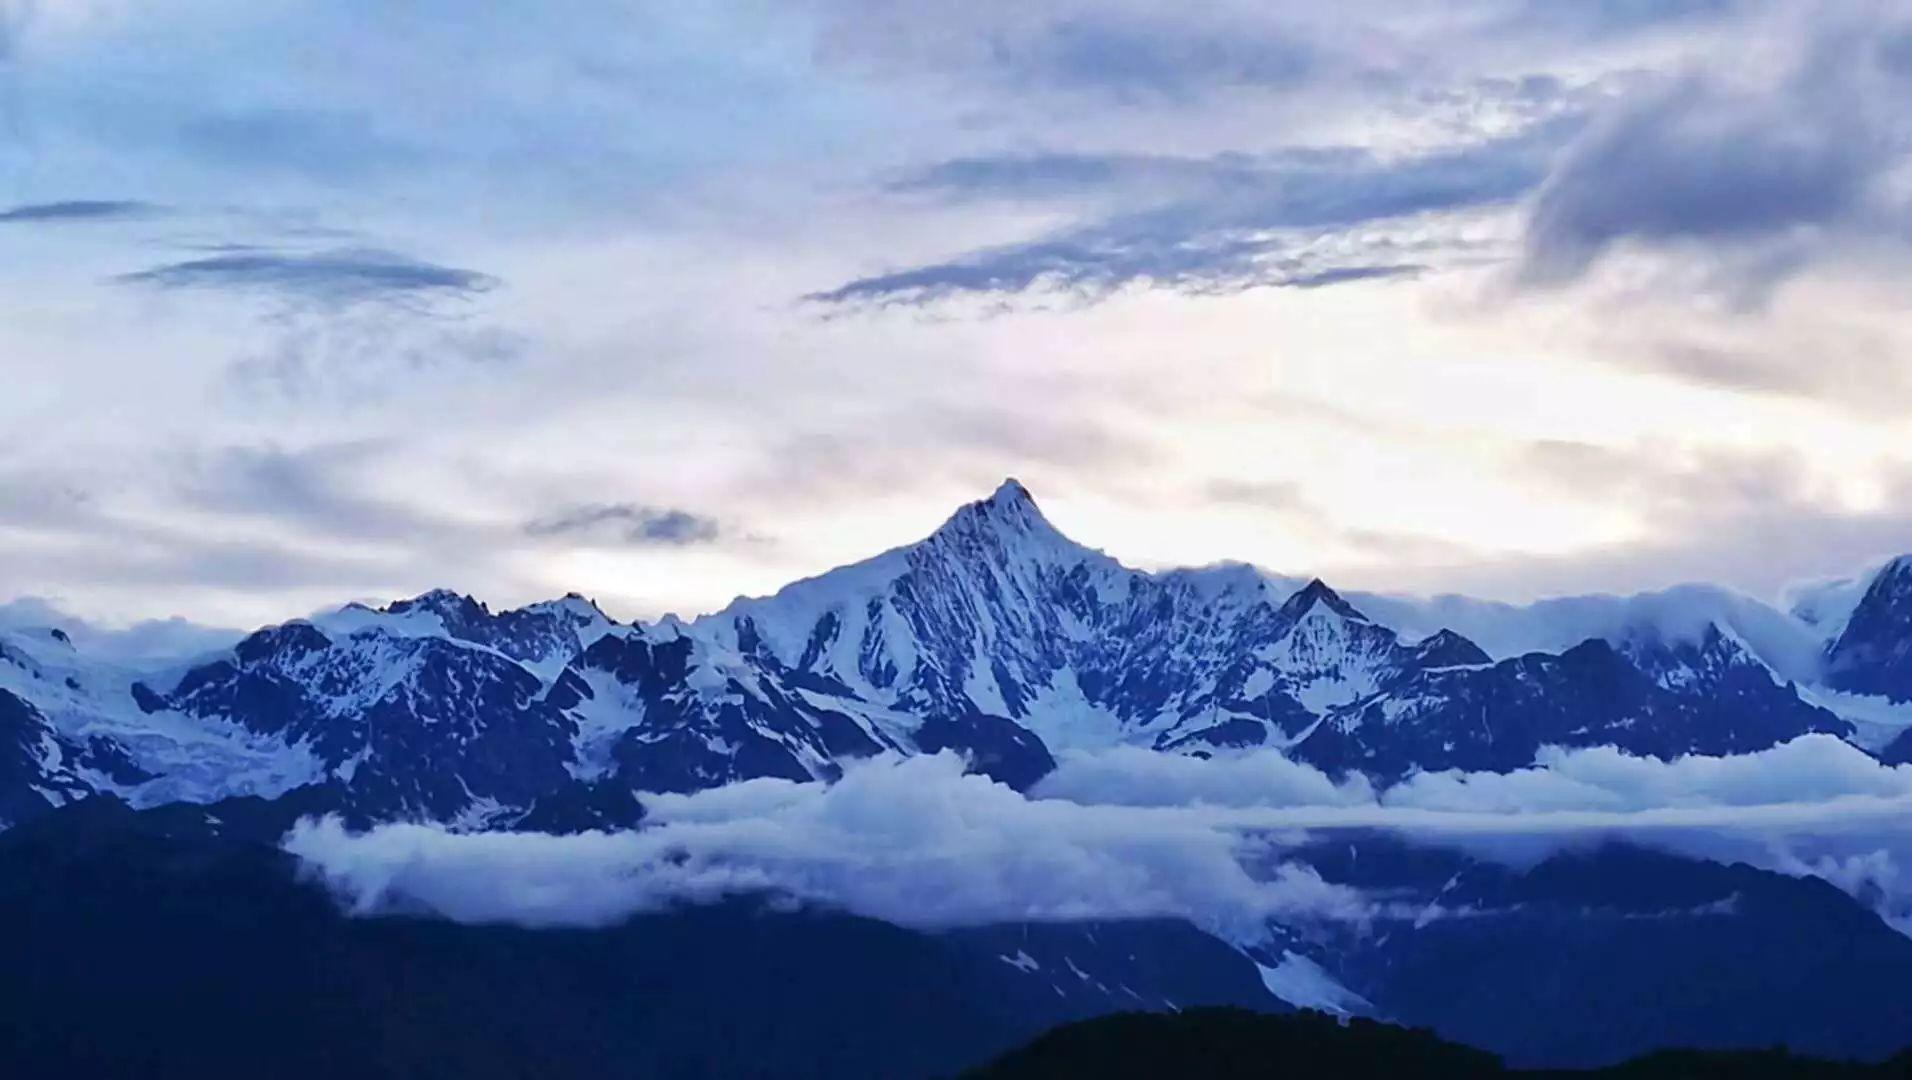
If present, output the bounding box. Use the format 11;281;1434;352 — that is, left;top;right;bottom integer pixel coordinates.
120;248;497;306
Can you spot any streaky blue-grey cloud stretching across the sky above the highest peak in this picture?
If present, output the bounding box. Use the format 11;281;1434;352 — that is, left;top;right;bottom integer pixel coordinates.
809;119;1577;304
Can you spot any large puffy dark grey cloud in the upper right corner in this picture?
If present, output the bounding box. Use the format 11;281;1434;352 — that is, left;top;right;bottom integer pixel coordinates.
1522;17;1912;286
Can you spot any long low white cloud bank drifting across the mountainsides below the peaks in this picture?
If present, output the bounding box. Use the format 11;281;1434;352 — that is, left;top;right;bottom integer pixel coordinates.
285;736;1912;942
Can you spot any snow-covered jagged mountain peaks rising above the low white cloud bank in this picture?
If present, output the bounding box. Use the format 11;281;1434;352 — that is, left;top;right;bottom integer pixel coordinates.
0;480;1912;830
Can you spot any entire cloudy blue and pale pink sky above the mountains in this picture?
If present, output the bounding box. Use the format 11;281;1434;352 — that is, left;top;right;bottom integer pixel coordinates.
0;0;1912;625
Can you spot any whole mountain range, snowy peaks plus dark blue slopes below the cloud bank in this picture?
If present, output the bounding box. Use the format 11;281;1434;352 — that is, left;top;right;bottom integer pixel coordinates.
0;482;1912;1076
